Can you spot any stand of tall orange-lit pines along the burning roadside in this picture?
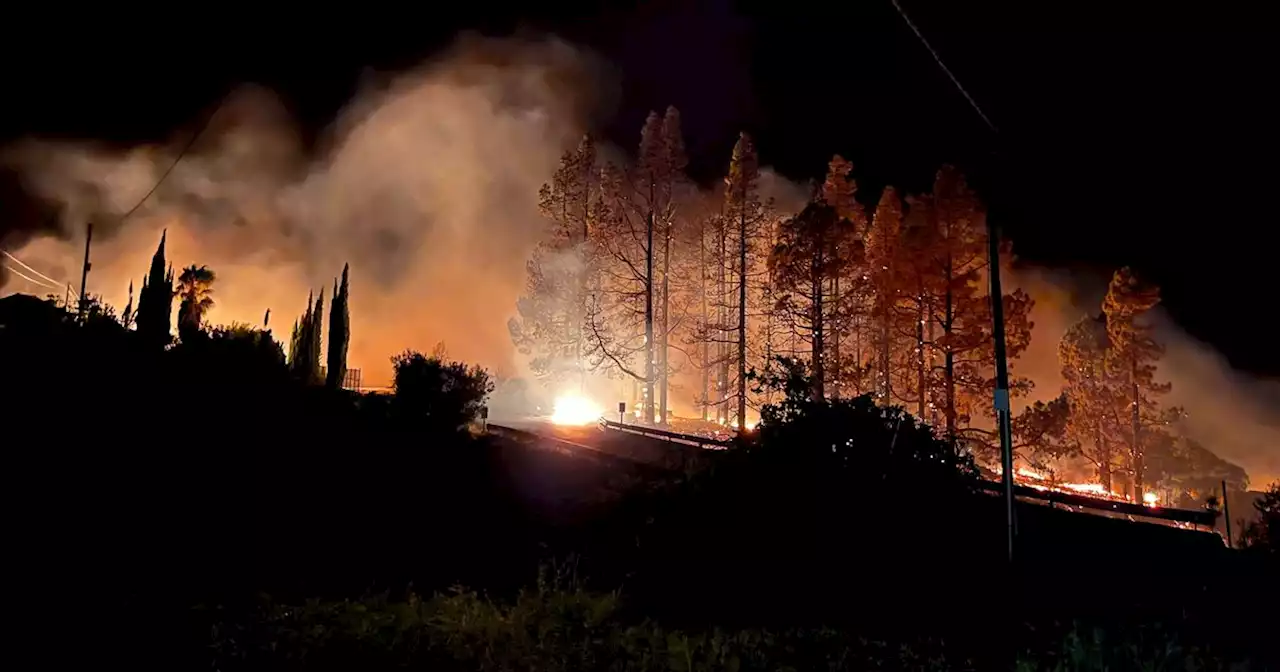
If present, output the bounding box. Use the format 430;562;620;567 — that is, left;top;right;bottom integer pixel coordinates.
511;108;1247;499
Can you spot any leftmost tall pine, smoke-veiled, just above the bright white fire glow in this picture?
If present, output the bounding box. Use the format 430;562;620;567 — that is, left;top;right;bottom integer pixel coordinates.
508;136;600;385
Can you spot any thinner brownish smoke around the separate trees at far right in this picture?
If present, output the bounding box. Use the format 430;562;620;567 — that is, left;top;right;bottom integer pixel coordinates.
1012;269;1280;489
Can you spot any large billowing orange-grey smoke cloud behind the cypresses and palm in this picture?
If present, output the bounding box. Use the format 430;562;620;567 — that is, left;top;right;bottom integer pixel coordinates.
4;37;600;385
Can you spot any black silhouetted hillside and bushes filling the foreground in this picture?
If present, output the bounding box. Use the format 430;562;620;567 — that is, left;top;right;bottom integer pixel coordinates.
0;296;1280;671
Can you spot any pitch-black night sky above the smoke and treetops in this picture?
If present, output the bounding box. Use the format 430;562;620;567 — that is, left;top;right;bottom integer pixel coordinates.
0;0;1280;376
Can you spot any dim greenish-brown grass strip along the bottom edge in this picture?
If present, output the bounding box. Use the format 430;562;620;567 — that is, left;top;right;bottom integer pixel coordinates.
199;570;1265;672
